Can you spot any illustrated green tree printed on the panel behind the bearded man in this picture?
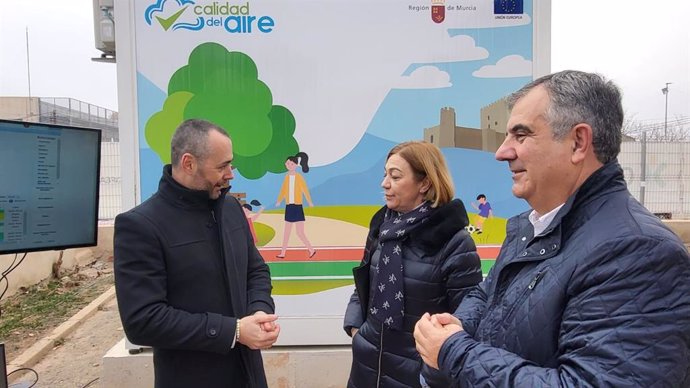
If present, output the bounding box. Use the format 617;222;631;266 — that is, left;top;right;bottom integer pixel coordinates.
145;43;299;179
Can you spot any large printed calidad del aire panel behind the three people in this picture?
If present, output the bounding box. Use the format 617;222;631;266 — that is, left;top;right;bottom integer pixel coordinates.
134;0;535;343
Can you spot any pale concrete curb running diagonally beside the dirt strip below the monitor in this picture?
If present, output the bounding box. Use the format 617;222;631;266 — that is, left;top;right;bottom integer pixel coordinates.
7;286;115;380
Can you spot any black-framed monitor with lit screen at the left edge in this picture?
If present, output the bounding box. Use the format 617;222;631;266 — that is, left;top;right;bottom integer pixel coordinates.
0;120;101;254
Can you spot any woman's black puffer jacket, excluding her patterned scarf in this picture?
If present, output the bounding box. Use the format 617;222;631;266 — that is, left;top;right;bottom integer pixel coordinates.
344;199;482;388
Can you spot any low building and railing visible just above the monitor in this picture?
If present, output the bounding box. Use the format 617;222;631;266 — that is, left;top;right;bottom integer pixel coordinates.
0;97;120;141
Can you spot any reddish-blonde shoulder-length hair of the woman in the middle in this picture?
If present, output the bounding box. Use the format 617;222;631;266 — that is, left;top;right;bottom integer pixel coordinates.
386;141;455;207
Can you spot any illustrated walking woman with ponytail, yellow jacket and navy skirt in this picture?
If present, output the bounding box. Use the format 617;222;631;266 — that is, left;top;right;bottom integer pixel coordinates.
276;152;316;259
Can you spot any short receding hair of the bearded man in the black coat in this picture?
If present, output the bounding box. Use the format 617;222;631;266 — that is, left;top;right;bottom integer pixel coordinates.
170;119;230;166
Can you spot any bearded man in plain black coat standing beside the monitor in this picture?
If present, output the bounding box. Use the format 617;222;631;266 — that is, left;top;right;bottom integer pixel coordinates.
114;120;280;388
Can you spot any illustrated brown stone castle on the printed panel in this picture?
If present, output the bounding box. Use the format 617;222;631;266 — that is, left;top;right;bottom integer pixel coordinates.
424;99;508;152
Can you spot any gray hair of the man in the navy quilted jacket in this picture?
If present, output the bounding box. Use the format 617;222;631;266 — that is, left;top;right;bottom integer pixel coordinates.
508;70;623;164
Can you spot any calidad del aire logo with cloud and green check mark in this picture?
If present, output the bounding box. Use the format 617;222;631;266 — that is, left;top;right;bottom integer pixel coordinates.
144;0;275;34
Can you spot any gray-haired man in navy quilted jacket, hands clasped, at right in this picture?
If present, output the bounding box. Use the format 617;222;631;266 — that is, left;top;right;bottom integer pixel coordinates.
415;71;690;387
